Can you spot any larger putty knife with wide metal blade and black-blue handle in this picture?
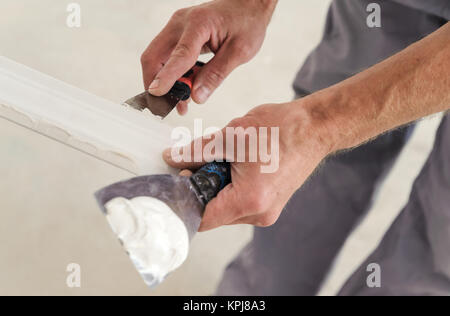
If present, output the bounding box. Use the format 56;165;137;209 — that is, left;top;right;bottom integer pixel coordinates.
95;162;231;287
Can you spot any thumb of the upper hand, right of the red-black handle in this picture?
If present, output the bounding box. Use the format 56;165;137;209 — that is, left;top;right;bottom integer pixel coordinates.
192;42;250;104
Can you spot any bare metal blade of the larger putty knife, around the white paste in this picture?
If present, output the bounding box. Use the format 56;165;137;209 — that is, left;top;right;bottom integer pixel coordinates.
95;175;204;287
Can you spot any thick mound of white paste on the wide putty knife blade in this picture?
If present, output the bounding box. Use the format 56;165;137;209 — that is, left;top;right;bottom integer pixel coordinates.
105;197;189;287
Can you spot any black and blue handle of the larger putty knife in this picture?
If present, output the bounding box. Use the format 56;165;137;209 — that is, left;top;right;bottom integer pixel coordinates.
191;162;231;206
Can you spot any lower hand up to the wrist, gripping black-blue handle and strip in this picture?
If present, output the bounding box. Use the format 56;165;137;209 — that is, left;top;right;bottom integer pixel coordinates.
164;98;332;231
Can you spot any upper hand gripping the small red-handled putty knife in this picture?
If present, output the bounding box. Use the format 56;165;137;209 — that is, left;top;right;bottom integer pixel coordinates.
141;0;277;114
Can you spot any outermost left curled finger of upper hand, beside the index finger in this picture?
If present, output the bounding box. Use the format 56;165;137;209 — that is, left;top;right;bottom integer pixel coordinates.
141;25;181;90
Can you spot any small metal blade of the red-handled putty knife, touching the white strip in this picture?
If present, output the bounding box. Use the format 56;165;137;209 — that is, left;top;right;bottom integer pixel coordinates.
124;91;180;118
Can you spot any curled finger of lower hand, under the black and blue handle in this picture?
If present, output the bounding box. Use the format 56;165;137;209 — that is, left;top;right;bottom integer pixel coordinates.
199;183;241;232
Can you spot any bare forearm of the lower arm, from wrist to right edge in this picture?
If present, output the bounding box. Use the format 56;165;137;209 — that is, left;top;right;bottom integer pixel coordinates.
302;23;450;152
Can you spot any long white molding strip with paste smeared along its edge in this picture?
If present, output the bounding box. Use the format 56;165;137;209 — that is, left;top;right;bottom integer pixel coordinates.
0;56;173;175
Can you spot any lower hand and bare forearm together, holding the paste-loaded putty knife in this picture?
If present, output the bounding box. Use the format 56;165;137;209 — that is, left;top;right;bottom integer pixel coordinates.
164;23;450;231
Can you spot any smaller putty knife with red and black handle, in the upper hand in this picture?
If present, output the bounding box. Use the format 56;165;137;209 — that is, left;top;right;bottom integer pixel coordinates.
124;61;205;118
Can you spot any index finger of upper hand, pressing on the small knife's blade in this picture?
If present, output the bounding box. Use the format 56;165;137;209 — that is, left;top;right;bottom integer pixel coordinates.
149;27;209;96
